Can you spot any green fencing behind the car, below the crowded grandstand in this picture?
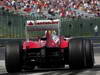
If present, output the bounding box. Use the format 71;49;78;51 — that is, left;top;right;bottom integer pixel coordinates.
0;10;100;38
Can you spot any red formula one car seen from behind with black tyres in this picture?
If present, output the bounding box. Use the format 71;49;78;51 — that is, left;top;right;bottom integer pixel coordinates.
5;19;94;72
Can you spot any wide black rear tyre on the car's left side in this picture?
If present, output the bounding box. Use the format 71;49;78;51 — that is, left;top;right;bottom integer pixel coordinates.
5;43;21;73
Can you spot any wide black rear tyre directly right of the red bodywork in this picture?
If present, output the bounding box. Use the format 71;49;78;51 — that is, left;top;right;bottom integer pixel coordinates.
69;38;85;69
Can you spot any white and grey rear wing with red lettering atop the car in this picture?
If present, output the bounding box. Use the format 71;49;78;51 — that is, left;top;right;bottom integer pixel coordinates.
26;19;60;31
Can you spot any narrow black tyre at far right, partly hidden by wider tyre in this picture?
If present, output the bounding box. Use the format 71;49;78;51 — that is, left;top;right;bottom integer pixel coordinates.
84;40;94;68
